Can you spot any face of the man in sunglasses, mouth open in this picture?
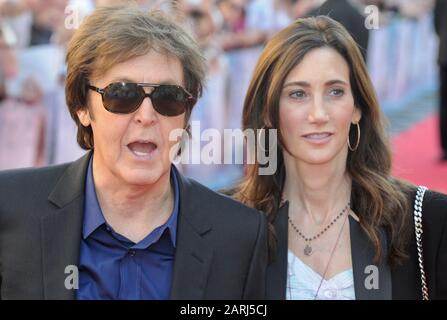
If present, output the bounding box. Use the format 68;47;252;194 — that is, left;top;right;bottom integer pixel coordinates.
78;50;185;186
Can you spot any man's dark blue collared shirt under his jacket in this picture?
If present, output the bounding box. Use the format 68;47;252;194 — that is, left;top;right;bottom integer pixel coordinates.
76;157;179;300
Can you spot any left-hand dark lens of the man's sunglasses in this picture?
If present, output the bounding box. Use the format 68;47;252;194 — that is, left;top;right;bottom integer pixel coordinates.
103;82;144;113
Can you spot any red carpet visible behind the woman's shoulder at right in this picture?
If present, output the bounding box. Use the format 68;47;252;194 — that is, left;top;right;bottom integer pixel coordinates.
392;116;447;193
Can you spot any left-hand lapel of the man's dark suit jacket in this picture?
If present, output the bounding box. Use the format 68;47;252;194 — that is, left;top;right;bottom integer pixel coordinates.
41;152;92;299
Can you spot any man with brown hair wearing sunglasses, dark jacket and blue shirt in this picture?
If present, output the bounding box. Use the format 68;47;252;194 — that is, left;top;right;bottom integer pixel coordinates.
0;6;267;299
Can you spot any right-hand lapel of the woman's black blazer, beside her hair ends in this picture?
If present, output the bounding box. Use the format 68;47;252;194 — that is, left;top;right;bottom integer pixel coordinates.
349;216;392;300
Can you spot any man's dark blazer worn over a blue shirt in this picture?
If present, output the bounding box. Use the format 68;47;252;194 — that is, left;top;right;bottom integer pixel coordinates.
0;153;267;299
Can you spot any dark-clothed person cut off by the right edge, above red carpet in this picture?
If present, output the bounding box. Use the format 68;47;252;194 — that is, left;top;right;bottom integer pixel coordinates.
434;0;447;161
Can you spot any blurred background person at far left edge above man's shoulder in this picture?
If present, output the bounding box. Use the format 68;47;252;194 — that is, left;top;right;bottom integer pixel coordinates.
0;24;46;170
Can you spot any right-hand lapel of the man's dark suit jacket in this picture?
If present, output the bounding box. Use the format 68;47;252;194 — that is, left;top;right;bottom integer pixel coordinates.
171;168;213;300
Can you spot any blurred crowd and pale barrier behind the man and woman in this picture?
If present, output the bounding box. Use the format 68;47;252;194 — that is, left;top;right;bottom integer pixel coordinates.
0;0;436;186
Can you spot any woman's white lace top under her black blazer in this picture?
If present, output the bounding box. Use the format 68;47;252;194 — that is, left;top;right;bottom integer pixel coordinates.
286;250;355;300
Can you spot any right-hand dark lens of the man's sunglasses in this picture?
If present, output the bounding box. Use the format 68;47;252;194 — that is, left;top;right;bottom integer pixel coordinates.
151;85;189;117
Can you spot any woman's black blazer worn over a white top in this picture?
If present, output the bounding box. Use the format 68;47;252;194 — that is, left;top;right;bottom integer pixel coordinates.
267;191;447;300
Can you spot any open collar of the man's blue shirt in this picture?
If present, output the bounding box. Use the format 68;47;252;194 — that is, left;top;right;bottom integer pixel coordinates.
82;155;180;247
